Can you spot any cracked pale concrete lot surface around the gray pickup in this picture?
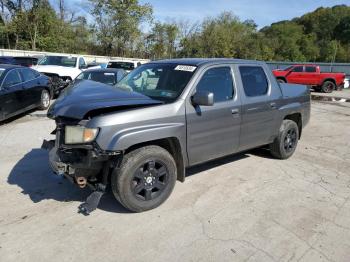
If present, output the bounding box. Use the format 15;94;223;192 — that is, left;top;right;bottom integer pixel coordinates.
0;99;350;261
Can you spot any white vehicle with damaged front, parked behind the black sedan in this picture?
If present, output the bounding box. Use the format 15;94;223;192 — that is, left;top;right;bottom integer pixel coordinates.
33;55;87;95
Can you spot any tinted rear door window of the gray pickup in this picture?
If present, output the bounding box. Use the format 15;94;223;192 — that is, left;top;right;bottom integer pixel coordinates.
239;66;269;97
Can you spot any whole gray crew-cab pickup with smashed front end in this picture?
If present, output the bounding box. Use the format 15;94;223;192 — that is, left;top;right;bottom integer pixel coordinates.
44;59;310;213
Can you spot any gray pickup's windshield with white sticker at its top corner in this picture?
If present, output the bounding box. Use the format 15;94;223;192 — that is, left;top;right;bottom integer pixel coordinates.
116;64;196;103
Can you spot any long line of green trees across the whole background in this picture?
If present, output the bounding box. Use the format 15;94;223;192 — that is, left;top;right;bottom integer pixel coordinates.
0;0;350;62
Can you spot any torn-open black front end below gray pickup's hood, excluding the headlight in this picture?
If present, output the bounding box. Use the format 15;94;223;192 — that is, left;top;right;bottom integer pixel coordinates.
42;118;122;215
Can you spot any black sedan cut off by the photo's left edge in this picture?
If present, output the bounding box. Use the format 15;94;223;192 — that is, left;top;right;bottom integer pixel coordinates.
0;64;52;121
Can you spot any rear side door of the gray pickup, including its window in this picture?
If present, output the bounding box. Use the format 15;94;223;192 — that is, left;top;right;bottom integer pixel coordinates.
237;65;282;151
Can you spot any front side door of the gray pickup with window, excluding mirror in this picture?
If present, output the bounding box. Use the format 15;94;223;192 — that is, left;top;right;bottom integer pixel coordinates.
186;65;241;165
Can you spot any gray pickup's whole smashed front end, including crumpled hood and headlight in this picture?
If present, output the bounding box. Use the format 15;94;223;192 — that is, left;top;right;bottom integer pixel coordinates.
43;80;162;213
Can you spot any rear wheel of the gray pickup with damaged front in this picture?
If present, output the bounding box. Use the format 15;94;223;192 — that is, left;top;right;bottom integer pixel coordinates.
270;120;299;159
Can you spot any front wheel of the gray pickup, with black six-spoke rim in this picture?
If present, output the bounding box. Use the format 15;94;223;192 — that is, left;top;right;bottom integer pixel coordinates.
111;146;177;212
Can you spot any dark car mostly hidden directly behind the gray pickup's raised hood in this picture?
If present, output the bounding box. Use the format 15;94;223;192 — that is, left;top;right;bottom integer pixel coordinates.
76;68;127;85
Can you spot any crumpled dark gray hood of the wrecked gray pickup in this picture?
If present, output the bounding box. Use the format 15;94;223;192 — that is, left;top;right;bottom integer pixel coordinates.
47;80;163;120
